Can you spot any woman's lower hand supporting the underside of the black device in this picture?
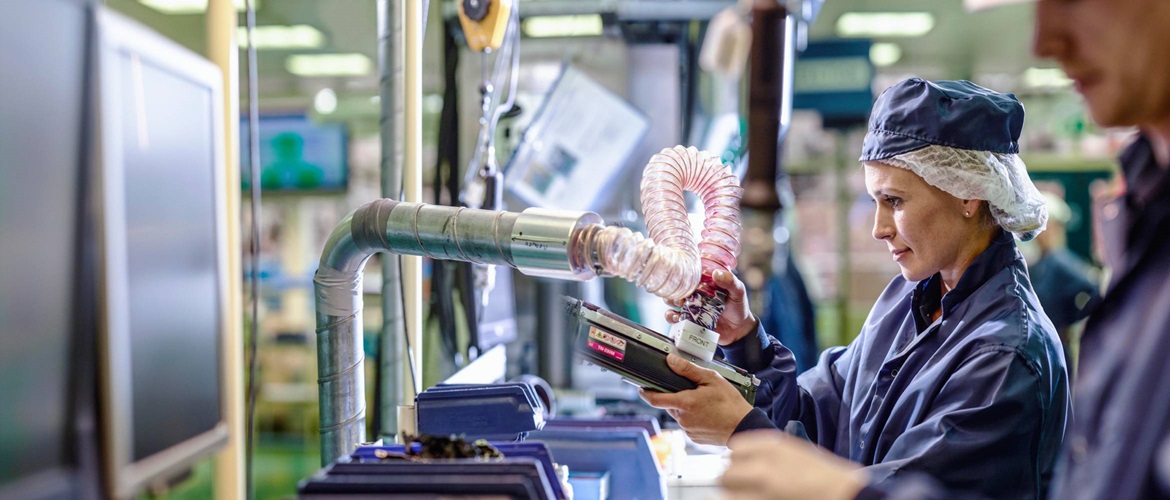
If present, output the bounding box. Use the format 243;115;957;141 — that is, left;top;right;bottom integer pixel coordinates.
638;352;751;445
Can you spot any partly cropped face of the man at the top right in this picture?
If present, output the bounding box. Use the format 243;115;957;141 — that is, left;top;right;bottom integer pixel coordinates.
1032;0;1170;126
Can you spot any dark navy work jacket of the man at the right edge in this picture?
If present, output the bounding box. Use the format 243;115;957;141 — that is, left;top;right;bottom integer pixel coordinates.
1053;138;1170;499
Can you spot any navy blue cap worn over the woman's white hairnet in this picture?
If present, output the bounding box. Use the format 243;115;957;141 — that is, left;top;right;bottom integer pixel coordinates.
859;78;1024;162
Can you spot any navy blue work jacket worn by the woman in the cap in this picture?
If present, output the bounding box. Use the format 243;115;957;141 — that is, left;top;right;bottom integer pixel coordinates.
724;232;1069;498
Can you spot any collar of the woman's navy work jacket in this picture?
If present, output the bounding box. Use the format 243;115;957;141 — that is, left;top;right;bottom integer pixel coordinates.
910;230;1023;333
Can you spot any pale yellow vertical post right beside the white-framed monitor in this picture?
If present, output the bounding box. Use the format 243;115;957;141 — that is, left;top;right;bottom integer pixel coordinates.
207;0;246;499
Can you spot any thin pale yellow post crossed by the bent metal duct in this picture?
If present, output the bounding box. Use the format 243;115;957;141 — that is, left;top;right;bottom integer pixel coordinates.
402;0;424;404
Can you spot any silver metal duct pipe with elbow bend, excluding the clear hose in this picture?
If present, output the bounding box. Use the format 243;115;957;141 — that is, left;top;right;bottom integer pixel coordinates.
312;199;601;465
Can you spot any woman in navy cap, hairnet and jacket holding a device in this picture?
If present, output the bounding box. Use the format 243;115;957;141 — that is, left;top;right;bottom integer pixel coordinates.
642;78;1068;498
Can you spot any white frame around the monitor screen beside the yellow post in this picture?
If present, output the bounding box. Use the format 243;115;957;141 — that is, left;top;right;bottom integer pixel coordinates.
96;8;230;498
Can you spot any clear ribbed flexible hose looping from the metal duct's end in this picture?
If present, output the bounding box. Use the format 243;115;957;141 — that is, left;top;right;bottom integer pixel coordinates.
584;146;743;309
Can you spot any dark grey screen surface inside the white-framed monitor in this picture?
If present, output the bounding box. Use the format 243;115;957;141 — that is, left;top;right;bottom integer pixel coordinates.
115;53;222;461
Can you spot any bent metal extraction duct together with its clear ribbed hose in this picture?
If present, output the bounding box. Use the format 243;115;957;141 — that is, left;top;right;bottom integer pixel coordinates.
314;146;743;465
